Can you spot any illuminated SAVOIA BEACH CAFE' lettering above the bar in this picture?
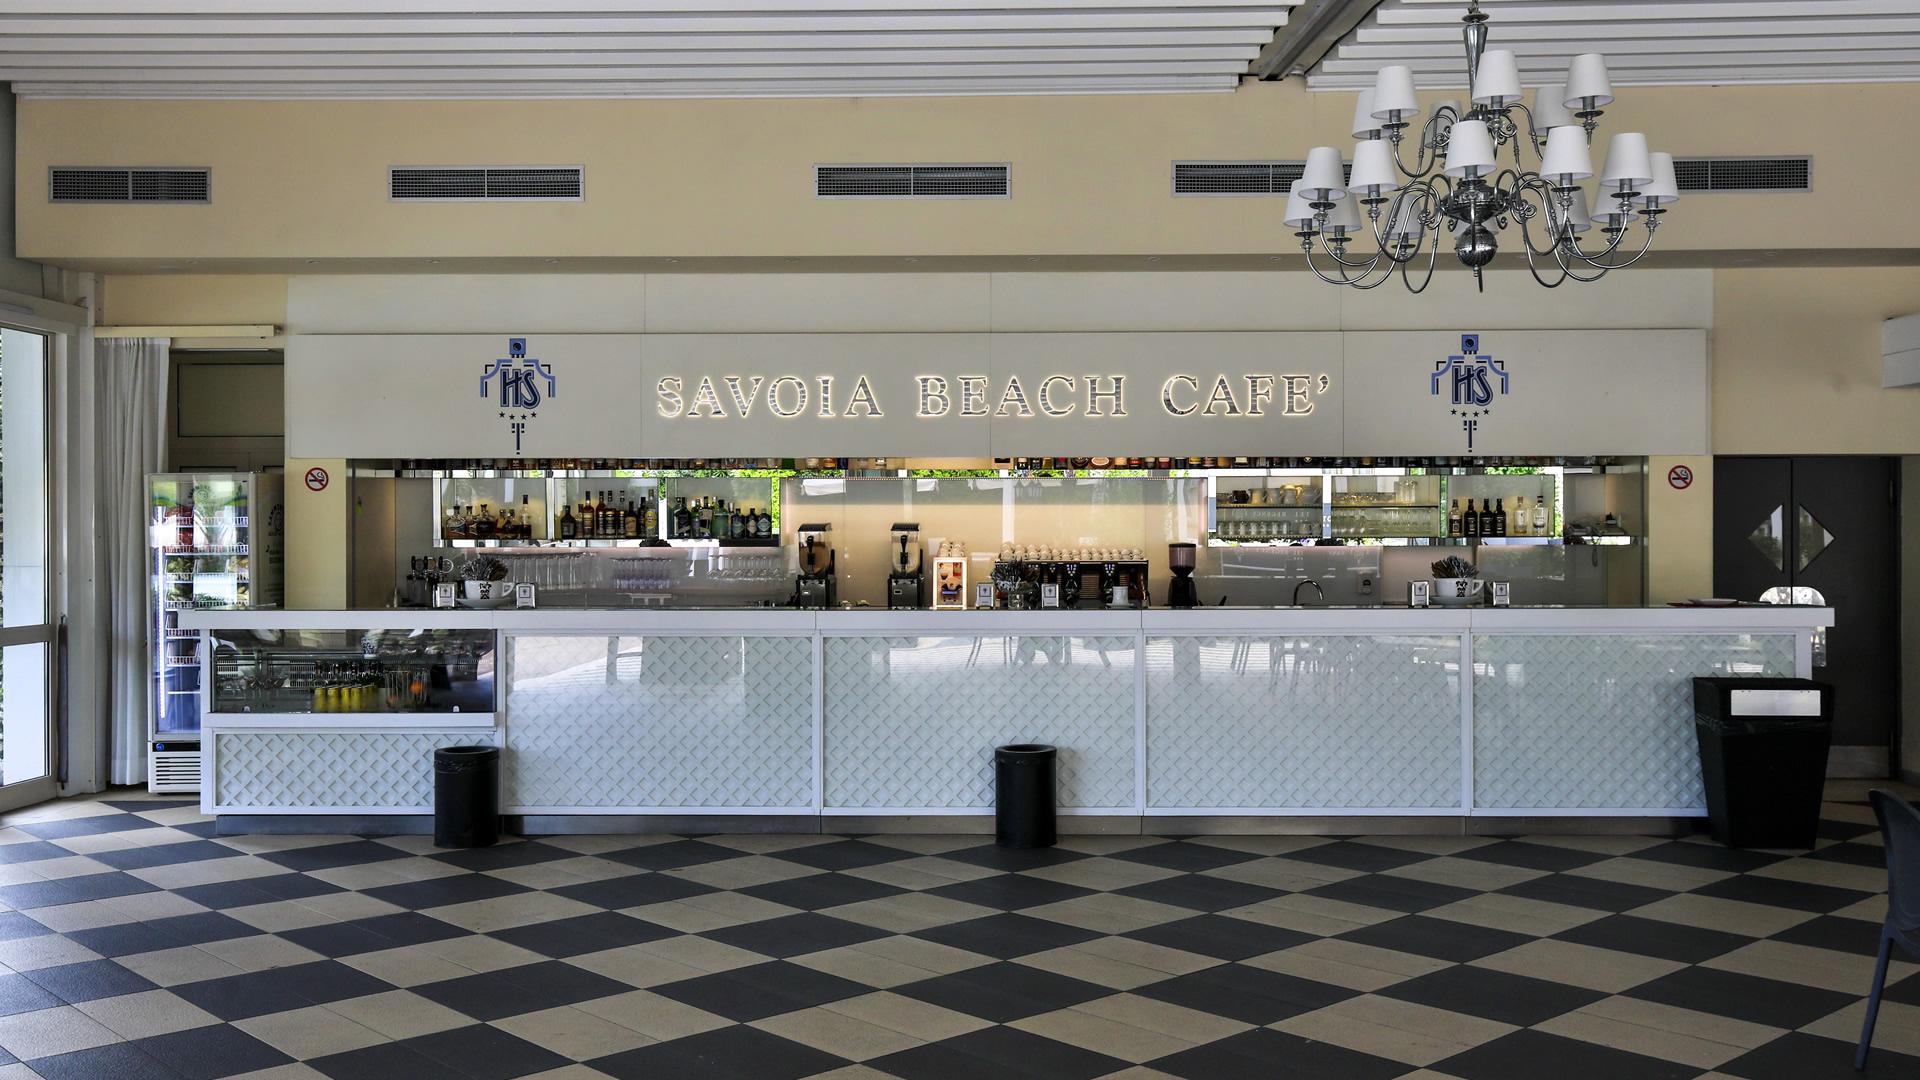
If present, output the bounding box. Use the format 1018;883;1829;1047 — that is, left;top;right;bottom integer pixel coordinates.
653;373;1332;421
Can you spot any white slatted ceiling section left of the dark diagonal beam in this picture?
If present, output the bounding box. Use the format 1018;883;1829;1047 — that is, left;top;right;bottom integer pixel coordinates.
0;0;1302;98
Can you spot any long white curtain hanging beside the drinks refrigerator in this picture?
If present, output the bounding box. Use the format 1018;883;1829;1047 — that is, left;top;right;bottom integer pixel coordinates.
94;338;169;784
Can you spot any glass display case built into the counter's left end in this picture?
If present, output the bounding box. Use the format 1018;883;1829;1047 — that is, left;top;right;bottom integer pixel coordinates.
205;630;495;724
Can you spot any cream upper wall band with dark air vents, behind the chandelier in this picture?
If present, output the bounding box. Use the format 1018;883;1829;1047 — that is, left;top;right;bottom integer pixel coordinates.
15;81;1920;263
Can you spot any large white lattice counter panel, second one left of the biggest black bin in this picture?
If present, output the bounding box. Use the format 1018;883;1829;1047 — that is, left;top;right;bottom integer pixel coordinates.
1146;634;1461;809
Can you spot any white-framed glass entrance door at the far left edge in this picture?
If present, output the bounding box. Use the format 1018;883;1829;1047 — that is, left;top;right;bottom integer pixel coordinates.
0;327;56;809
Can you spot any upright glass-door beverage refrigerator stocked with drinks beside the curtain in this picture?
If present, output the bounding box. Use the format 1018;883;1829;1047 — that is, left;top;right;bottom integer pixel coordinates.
146;473;286;792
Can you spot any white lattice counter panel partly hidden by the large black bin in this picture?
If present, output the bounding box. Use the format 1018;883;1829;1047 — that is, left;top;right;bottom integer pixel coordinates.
1473;634;1793;809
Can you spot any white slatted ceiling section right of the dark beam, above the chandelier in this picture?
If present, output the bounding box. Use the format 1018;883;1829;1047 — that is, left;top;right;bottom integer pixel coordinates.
1308;0;1920;90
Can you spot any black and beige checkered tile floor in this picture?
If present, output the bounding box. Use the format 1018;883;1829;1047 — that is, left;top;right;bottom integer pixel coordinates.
0;784;1920;1080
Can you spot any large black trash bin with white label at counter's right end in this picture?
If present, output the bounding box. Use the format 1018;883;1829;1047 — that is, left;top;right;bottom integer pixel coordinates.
1693;678;1834;847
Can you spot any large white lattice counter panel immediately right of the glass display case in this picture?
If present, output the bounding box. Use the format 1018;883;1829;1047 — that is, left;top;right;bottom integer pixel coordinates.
505;636;814;807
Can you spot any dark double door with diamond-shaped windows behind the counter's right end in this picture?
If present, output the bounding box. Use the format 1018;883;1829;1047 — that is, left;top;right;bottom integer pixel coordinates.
1713;457;1899;748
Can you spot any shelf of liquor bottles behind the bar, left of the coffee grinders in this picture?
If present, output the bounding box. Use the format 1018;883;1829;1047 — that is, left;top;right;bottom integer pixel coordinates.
430;473;780;548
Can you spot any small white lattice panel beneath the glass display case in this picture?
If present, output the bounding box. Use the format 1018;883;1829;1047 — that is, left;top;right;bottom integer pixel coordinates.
213;732;511;813
